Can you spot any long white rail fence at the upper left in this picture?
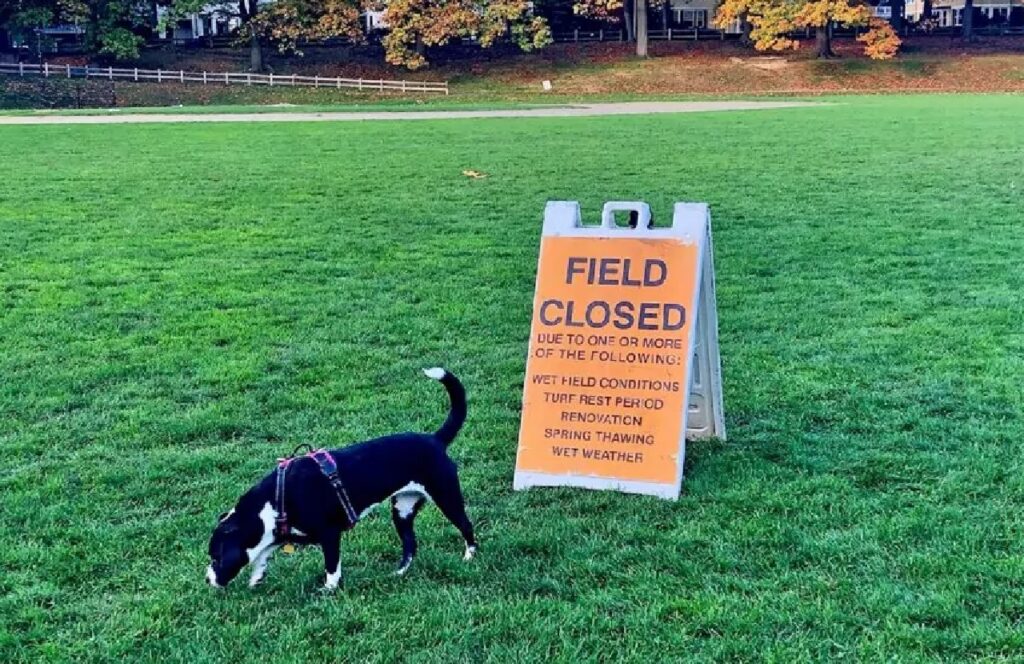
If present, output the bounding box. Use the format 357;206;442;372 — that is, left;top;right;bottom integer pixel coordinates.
0;63;449;94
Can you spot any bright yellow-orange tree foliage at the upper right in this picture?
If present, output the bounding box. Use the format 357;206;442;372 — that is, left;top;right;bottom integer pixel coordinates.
715;0;901;59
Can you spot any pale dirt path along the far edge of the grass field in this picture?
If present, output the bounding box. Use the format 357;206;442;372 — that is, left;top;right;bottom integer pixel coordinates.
0;101;819;125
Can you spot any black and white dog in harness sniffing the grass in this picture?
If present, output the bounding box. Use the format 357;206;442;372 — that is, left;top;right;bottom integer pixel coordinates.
206;369;476;590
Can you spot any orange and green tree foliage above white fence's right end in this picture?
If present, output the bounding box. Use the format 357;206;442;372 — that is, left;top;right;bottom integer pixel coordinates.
380;0;551;69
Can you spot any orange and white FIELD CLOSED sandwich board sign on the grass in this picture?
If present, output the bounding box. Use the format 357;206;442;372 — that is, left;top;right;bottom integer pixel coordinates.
514;201;725;499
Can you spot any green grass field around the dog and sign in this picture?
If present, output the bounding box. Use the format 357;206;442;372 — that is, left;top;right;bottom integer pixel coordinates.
0;96;1024;662
